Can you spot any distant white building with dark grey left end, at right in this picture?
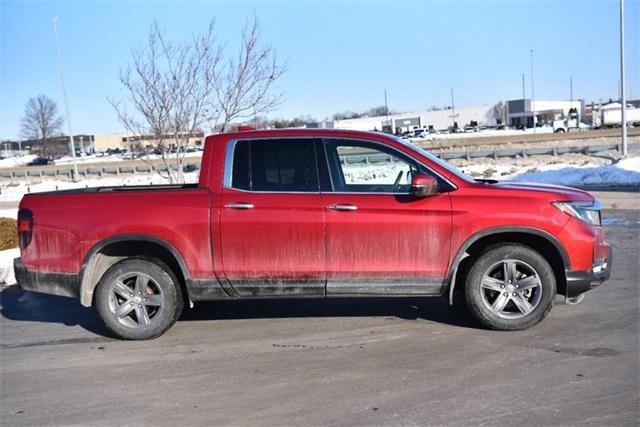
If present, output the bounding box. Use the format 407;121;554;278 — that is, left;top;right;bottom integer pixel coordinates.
507;99;585;128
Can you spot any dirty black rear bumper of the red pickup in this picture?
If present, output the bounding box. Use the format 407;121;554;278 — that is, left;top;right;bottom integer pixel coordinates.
13;258;80;298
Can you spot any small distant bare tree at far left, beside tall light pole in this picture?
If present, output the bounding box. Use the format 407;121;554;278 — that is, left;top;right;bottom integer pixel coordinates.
20;95;64;154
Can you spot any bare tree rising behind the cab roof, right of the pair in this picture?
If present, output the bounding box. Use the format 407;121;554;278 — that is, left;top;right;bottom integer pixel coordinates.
210;16;287;132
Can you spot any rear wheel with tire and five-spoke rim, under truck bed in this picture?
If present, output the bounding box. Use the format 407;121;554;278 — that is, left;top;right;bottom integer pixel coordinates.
95;258;183;340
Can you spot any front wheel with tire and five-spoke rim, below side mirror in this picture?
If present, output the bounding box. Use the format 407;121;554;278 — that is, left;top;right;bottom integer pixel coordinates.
465;244;556;331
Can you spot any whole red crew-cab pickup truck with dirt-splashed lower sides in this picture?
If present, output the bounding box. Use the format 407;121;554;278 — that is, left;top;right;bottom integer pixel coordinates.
14;129;611;339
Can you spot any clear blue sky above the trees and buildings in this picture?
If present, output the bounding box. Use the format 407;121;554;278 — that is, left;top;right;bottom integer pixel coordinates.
0;0;640;139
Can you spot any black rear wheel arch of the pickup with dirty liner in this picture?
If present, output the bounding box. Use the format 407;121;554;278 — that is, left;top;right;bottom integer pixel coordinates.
80;234;190;307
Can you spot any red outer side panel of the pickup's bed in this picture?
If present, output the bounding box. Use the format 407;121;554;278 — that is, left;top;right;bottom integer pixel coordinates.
20;184;212;277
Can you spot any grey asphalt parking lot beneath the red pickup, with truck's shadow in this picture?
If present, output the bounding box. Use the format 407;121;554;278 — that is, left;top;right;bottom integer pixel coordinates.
0;210;640;426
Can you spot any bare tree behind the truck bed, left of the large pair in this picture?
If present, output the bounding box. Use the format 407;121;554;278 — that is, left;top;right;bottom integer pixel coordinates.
109;21;221;183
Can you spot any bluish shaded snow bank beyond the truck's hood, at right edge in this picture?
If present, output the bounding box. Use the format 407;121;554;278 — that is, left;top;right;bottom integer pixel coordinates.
502;157;640;187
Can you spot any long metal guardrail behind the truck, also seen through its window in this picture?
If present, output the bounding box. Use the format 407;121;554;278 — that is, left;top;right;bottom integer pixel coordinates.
0;143;640;178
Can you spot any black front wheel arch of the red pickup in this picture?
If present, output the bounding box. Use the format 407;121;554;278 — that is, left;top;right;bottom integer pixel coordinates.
445;226;571;305
